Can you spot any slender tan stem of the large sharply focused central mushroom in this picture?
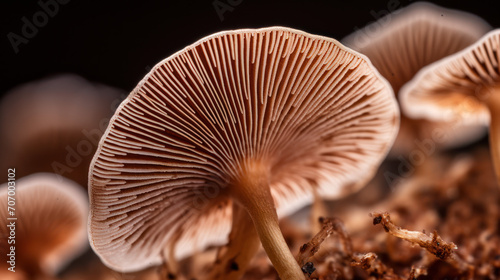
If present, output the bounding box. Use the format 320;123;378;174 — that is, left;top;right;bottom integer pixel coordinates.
233;162;305;280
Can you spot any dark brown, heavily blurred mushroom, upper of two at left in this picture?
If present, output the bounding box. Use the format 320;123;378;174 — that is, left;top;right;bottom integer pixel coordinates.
0;74;123;186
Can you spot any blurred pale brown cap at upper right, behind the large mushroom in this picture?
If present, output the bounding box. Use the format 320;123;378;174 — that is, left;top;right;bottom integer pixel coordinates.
342;2;491;94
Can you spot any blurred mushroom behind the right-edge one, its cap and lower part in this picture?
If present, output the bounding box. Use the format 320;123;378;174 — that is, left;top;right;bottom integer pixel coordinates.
342;2;491;156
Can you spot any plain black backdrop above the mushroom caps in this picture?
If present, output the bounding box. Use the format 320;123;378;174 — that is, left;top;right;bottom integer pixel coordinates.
0;0;500;94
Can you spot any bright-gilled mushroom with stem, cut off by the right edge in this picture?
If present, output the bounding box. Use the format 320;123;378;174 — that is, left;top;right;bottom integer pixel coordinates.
401;29;500;185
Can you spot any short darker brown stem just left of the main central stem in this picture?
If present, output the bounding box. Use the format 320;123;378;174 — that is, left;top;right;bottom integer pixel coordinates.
209;202;260;280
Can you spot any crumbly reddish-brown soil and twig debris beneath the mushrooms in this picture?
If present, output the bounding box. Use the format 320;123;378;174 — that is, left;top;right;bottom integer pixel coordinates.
64;150;500;280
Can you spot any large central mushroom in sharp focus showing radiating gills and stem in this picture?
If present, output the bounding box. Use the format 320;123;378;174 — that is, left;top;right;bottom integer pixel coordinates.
89;27;399;279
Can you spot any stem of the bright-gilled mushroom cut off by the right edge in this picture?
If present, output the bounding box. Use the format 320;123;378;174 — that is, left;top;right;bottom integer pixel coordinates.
486;90;500;186
